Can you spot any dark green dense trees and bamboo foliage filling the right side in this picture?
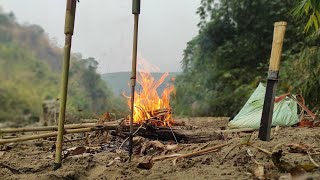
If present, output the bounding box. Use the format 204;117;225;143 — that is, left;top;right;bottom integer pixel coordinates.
173;0;320;116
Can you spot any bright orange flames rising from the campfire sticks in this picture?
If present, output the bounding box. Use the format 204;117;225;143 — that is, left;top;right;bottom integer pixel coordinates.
127;69;174;126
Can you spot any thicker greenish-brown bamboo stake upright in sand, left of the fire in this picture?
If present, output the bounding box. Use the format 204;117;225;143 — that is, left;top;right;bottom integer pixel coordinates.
53;0;77;170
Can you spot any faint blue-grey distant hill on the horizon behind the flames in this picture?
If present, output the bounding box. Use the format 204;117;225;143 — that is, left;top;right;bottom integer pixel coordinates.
101;72;179;96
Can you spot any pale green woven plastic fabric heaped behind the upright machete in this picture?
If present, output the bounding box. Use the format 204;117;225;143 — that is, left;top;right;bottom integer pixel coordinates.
228;83;299;129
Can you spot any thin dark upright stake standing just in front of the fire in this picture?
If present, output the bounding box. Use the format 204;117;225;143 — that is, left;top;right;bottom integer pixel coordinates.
129;0;140;161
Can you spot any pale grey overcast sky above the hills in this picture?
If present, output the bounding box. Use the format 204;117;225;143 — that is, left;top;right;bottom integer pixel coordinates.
0;0;200;73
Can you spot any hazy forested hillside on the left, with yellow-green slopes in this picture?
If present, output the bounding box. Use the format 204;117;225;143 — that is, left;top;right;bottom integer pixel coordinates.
0;8;124;125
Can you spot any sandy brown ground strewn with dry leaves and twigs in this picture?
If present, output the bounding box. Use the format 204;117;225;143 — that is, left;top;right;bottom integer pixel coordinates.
0;118;320;180
